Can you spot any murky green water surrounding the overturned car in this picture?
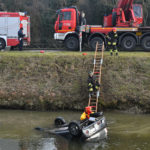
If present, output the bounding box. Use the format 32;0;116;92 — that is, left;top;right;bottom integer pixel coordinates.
0;110;150;150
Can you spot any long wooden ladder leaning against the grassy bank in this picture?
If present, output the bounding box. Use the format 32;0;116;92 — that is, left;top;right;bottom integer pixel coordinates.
88;42;104;112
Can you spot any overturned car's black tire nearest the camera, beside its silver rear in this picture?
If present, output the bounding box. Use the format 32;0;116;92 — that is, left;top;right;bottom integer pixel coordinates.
68;121;82;137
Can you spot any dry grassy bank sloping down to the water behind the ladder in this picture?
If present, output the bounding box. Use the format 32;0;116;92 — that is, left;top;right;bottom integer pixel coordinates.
0;52;150;113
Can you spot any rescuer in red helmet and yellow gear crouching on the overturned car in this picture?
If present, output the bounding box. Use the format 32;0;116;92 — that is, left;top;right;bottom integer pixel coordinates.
80;106;93;121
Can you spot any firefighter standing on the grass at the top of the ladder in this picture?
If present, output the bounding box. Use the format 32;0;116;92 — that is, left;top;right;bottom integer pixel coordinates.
107;29;118;56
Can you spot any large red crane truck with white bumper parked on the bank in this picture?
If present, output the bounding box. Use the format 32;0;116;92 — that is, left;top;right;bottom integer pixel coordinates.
54;0;150;51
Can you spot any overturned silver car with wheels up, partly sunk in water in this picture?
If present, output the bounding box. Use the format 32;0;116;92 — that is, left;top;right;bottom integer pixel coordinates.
49;112;107;140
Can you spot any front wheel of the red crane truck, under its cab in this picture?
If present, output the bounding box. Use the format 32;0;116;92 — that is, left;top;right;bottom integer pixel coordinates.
65;36;79;50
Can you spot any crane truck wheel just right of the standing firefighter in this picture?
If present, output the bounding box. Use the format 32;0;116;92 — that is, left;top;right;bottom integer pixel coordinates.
121;36;136;51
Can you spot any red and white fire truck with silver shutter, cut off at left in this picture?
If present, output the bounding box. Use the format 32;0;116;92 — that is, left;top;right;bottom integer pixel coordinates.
0;12;31;50
